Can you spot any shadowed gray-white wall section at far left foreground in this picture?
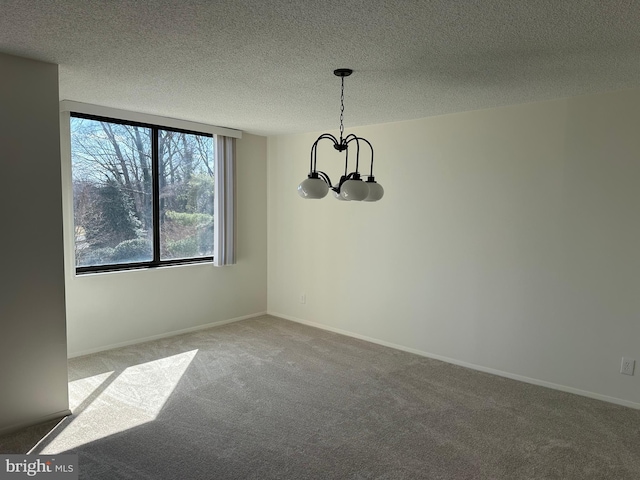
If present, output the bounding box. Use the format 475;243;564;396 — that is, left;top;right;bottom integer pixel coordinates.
0;54;69;431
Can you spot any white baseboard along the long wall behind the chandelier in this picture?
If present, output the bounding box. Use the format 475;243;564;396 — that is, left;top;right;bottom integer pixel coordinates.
267;312;640;410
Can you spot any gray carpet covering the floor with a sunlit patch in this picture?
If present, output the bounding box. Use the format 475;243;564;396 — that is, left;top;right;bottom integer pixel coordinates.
0;317;640;480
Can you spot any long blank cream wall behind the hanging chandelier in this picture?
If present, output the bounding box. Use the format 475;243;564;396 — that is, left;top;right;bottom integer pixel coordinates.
268;90;640;407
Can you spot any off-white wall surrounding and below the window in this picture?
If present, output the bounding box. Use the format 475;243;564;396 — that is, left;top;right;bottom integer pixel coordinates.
63;131;267;356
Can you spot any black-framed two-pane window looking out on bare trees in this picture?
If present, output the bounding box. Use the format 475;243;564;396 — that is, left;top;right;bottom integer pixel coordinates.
70;113;216;273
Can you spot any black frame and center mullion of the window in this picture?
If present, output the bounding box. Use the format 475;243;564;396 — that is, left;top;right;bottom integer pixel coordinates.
69;111;216;275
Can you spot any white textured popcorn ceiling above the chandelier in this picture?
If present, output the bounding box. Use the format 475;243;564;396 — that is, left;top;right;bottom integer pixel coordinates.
0;0;640;134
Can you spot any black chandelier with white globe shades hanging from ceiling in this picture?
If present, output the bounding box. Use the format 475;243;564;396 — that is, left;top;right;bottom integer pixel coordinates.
298;68;384;202
